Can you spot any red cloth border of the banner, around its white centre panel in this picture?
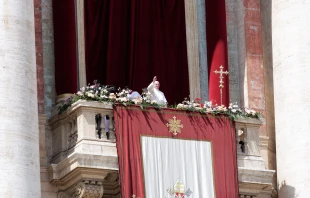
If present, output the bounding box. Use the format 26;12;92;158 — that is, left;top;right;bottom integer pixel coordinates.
114;106;238;198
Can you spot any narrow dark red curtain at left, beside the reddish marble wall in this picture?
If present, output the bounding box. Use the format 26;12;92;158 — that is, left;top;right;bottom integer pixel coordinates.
53;0;78;95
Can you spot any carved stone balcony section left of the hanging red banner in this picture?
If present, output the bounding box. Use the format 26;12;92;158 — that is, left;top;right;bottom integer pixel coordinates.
48;101;120;198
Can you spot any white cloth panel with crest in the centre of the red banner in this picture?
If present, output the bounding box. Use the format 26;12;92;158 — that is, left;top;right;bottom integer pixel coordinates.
141;136;215;198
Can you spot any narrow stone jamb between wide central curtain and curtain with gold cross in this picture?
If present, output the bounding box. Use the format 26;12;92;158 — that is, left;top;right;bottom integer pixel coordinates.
184;0;208;101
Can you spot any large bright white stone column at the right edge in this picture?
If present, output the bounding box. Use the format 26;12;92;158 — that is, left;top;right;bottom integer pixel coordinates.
272;0;310;198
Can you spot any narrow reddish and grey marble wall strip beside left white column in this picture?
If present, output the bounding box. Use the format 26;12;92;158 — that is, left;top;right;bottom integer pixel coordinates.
34;0;58;198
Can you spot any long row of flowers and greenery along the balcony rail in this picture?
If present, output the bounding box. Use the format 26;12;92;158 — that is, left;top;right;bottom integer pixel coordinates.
58;81;262;120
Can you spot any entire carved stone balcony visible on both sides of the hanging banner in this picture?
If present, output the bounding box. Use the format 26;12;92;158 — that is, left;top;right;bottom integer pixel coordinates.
48;100;275;198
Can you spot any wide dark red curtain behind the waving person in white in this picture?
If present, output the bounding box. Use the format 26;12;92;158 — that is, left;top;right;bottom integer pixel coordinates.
85;0;189;104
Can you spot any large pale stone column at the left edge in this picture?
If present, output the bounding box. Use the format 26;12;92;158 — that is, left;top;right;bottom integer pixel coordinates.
0;0;40;198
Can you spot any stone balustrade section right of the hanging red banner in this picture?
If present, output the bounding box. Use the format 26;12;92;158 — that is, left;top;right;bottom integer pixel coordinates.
235;118;275;198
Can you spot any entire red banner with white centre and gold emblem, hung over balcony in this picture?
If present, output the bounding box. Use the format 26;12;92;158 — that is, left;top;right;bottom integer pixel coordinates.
114;106;238;198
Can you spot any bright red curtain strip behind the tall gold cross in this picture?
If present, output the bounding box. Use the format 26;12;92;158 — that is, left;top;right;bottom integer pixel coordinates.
205;0;229;106
